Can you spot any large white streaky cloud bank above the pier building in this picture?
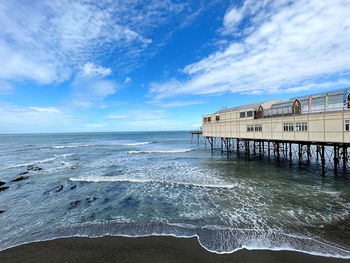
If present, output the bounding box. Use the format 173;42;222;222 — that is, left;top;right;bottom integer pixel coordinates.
150;0;350;99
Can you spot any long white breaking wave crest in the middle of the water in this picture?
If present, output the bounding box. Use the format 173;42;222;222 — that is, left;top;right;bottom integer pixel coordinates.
69;176;237;189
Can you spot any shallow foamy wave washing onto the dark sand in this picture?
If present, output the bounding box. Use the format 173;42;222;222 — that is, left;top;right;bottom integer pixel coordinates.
0;222;350;259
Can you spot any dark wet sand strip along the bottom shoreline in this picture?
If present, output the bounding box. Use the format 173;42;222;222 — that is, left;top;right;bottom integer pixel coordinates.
0;237;350;263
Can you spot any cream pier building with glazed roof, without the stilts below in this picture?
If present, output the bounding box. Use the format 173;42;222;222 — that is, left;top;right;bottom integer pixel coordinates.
202;89;350;144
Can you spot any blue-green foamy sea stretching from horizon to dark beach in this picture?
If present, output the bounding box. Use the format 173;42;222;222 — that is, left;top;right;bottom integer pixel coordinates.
0;132;350;258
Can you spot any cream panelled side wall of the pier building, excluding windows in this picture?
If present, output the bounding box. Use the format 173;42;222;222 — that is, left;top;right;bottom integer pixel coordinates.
202;109;350;143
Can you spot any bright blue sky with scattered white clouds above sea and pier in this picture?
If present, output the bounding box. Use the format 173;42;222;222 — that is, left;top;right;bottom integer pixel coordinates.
0;0;350;133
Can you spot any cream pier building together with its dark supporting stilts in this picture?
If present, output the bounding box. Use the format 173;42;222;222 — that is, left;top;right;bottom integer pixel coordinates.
197;89;350;175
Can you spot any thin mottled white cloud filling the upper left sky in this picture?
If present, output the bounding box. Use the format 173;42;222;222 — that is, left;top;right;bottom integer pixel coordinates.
0;0;193;84
